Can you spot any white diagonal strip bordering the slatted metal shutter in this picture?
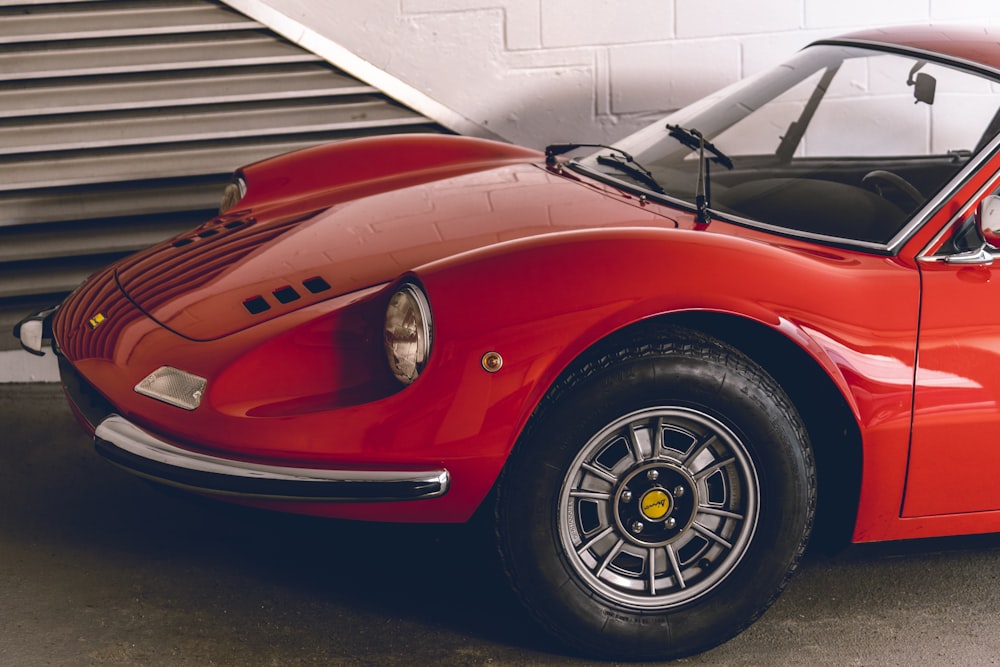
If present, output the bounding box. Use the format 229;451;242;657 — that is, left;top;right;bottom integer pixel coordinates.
222;0;505;141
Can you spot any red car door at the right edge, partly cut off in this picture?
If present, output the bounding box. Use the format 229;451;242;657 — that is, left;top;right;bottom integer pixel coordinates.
903;168;1000;517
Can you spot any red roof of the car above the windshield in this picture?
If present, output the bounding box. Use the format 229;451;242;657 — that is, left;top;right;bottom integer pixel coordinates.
824;25;1000;71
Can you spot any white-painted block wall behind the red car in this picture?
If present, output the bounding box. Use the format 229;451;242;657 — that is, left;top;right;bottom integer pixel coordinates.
230;0;1000;147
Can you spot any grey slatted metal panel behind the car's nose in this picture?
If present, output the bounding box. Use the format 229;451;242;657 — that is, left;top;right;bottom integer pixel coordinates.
0;0;447;334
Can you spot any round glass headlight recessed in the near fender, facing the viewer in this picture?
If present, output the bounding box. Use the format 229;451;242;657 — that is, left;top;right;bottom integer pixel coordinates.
385;283;431;384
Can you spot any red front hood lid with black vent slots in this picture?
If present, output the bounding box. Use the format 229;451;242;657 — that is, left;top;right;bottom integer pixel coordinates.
116;164;676;340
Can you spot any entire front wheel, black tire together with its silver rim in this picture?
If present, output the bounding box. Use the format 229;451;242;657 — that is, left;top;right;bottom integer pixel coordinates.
496;327;816;660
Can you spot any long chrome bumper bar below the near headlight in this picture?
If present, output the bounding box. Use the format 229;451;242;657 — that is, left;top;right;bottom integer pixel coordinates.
94;414;450;502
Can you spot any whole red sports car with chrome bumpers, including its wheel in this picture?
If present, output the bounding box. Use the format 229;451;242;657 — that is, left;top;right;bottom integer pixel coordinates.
16;23;1000;659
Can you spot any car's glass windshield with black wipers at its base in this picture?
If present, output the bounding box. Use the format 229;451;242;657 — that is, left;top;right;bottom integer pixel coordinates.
579;45;1000;244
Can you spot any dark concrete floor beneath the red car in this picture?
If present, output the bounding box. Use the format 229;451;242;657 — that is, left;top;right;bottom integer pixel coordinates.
0;385;1000;667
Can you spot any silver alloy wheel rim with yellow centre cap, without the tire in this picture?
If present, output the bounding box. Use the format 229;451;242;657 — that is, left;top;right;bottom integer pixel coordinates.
558;406;759;610
